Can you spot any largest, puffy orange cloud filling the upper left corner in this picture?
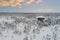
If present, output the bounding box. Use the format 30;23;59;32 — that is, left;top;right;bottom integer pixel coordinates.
0;0;24;7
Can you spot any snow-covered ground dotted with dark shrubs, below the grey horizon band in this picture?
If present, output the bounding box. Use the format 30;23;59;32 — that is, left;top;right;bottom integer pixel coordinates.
0;15;60;40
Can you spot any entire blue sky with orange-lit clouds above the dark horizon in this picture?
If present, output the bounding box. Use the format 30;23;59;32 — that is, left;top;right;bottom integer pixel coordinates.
0;0;60;12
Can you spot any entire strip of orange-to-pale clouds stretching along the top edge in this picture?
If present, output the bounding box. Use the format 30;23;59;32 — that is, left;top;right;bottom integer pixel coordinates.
0;0;42;7
